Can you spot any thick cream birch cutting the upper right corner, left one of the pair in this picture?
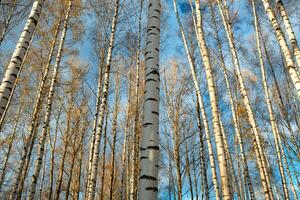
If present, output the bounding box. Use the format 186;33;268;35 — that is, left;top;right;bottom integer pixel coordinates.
262;0;300;99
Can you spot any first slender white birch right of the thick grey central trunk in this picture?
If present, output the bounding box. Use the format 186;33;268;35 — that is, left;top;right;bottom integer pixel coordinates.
173;1;220;200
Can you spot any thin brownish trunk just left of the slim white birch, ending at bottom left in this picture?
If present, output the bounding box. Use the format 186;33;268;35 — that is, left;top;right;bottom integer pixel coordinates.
11;19;61;199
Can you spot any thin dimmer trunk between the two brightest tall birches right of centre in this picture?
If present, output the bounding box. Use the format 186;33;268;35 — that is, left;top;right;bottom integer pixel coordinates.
209;3;255;200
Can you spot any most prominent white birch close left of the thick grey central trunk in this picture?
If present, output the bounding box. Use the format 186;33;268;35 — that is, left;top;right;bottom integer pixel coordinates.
87;0;120;200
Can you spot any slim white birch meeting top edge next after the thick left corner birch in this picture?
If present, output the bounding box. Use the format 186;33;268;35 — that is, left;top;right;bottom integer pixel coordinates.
28;0;73;200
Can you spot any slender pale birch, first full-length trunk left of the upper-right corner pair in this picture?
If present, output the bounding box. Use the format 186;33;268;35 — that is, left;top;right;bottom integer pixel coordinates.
252;0;289;199
